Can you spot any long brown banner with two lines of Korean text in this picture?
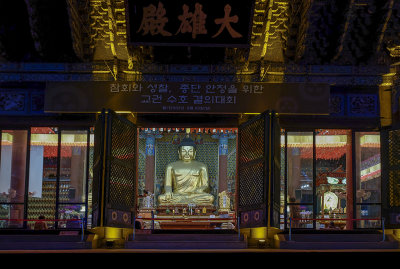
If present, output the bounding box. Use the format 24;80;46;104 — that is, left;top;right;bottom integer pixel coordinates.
44;81;330;115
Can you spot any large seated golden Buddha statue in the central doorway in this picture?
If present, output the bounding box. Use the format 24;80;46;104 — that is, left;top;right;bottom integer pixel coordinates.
158;136;214;206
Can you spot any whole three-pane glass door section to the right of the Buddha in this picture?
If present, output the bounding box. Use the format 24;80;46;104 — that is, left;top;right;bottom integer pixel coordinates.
282;129;382;230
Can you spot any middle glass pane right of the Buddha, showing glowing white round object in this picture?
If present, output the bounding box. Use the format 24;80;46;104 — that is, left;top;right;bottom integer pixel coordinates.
315;129;353;230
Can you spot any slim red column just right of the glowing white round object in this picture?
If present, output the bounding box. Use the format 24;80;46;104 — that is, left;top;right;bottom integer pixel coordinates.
346;133;354;230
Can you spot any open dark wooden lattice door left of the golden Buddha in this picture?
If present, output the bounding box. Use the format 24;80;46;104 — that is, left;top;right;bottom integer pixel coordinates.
93;110;137;227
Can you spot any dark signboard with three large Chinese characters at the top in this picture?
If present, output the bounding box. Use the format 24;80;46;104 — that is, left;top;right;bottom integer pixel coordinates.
127;0;254;46
